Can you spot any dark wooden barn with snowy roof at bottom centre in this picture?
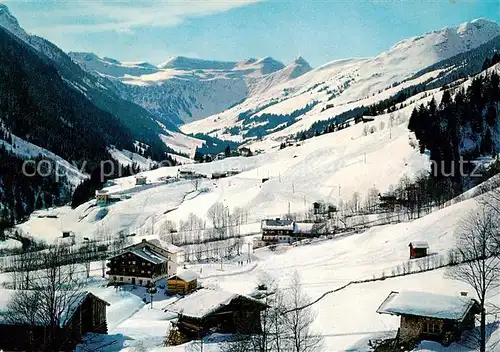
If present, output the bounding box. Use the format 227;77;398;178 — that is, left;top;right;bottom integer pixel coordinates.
165;289;267;341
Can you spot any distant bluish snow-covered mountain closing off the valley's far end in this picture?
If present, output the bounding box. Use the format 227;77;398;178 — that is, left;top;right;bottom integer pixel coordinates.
69;53;311;125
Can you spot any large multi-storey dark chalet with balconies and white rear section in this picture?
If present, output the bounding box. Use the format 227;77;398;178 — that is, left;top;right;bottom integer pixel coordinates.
107;239;183;286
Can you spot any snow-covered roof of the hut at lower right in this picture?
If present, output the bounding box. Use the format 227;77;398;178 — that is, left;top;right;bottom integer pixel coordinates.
377;291;476;321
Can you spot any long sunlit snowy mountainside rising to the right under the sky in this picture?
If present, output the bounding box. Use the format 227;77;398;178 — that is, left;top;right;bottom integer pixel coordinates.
182;19;500;139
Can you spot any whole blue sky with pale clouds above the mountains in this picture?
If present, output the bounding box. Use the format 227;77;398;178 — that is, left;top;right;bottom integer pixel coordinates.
0;0;500;66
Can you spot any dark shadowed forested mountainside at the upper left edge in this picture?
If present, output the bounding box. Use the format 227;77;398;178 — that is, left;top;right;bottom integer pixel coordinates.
0;29;133;170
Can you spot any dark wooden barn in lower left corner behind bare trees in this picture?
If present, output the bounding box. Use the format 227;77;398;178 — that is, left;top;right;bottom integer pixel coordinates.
0;291;109;351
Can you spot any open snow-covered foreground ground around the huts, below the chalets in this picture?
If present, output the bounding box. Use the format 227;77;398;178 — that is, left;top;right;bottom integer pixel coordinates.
7;194;500;352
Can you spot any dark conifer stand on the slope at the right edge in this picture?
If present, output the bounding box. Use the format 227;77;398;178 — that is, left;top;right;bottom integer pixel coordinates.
408;72;500;192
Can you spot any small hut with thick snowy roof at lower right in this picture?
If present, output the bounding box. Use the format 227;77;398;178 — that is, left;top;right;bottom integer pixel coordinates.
377;291;480;346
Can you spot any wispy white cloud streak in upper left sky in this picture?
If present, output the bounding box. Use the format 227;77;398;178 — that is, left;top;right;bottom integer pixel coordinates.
29;0;263;35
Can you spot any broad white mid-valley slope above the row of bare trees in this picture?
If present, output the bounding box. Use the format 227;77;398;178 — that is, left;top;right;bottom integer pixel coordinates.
20;97;429;248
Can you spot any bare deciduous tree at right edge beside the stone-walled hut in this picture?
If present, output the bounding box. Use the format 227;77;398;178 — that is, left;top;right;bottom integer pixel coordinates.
448;207;500;352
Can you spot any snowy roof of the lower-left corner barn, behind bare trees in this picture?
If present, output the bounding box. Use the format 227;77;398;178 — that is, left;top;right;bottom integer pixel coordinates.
0;290;109;327
